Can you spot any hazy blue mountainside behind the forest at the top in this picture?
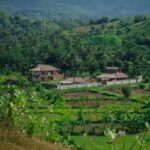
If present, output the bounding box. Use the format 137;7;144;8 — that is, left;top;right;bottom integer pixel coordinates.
0;0;150;19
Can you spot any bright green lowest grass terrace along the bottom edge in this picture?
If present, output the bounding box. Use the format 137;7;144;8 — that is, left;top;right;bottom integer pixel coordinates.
71;133;150;150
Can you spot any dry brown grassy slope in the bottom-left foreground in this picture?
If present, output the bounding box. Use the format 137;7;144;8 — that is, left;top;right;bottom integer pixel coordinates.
0;129;70;150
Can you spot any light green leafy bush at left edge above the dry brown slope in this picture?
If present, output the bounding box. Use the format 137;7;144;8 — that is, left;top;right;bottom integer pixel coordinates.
0;86;26;126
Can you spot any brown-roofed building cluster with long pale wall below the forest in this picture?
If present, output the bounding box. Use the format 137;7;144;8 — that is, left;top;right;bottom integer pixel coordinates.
30;64;142;88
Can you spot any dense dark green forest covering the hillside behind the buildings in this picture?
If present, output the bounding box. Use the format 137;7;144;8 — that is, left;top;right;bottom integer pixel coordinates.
0;12;150;80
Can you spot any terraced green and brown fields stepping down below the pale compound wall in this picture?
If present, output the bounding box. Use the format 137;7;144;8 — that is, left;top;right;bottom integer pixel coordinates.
18;85;150;150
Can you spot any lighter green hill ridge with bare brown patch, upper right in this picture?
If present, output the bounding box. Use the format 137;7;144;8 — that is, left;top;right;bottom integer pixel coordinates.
67;15;150;36
